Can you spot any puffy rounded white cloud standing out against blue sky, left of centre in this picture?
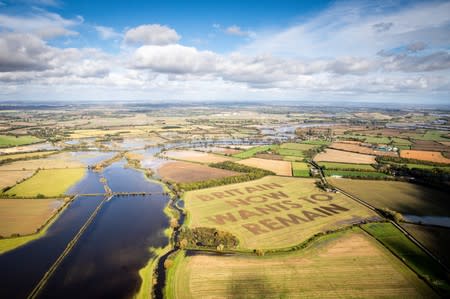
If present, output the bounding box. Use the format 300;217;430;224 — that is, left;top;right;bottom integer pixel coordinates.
125;24;181;46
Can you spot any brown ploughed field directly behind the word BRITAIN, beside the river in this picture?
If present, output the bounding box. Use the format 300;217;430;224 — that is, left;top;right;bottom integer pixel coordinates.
158;161;241;183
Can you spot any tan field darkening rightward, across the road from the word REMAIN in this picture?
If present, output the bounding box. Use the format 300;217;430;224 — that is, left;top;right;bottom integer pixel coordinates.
328;178;450;217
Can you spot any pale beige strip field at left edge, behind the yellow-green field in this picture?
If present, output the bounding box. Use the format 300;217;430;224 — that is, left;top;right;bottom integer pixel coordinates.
0;152;85;172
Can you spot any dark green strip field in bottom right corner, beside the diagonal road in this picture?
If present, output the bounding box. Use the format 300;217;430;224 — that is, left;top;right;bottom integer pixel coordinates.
362;223;450;295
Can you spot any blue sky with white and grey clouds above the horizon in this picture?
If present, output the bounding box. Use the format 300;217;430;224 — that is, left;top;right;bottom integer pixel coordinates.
0;0;450;104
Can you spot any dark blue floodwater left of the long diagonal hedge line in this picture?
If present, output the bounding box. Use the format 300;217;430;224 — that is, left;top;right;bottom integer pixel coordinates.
0;197;103;298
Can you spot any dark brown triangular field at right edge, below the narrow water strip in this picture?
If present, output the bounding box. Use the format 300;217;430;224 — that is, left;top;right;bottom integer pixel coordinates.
401;223;450;267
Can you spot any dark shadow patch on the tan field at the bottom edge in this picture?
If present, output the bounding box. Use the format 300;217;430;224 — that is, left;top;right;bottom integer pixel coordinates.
227;273;287;299
